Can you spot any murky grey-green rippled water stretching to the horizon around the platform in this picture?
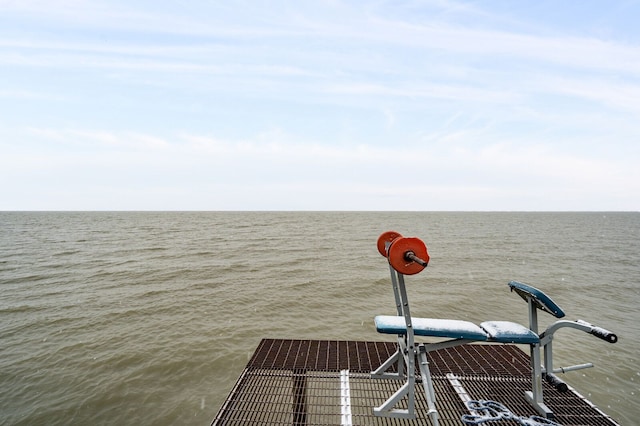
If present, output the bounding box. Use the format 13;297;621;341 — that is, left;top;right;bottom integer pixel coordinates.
0;212;640;425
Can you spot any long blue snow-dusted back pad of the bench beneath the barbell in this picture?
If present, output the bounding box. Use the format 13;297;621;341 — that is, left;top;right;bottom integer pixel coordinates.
375;315;488;341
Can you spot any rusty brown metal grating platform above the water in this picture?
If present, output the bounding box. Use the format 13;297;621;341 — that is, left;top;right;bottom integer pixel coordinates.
212;339;617;426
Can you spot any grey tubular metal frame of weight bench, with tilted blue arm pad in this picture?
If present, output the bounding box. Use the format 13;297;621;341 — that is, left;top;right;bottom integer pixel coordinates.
371;265;617;426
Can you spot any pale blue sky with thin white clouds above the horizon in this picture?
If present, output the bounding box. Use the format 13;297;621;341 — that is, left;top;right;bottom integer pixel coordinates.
0;0;640;211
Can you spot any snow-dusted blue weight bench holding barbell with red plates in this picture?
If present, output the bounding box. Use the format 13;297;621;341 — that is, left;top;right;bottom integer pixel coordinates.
371;231;618;426
